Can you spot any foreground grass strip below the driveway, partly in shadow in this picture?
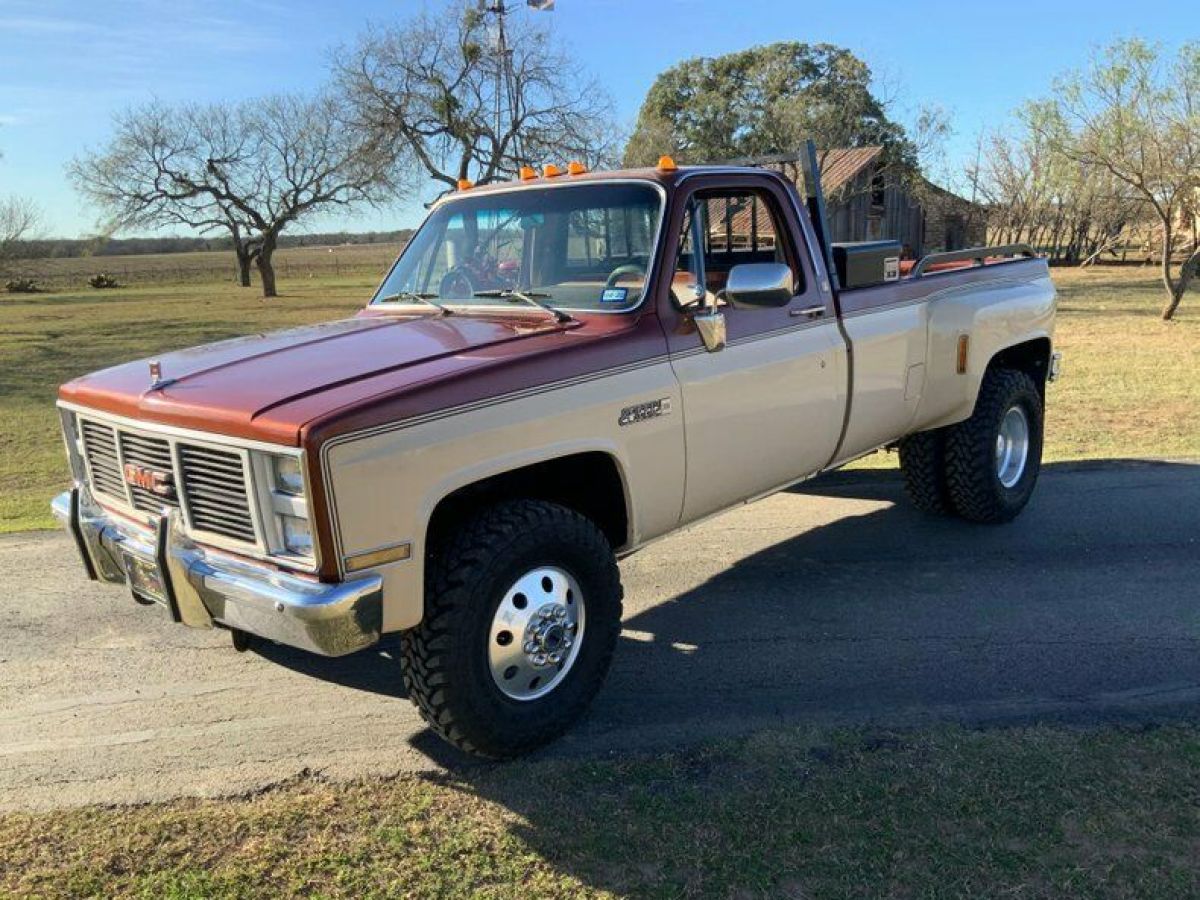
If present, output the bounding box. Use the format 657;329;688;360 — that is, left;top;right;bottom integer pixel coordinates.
0;727;1200;898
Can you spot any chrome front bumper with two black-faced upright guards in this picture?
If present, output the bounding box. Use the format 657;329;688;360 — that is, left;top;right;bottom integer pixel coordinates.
50;486;383;656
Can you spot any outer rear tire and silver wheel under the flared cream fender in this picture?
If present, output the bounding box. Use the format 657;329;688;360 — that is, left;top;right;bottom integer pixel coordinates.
946;368;1044;524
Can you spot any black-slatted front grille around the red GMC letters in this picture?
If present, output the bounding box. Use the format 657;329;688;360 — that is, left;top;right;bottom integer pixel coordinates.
78;416;258;544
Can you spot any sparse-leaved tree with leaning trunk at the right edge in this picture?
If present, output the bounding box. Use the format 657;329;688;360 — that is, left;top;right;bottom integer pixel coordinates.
1026;40;1200;319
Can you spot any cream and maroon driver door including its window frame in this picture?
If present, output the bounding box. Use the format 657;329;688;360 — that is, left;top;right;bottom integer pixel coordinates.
664;176;847;522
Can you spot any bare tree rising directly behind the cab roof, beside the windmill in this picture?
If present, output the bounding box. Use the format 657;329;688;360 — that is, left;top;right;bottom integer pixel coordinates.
335;2;620;190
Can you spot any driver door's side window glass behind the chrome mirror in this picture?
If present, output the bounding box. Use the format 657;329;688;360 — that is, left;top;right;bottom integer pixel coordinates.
672;188;804;305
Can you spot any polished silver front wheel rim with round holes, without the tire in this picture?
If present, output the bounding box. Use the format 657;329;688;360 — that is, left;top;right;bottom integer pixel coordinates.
487;566;584;700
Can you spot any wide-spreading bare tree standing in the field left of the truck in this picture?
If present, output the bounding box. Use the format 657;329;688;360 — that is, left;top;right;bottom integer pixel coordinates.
68;96;400;296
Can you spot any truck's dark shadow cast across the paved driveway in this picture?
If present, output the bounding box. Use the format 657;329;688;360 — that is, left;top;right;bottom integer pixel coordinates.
259;461;1200;768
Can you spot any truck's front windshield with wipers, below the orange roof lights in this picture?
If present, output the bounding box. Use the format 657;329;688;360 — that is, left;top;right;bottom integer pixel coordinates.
372;182;662;312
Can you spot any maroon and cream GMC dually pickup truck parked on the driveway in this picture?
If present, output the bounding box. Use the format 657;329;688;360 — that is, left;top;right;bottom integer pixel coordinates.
52;151;1057;758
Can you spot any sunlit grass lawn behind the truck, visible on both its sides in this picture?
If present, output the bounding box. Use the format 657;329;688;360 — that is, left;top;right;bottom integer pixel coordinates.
0;264;1200;532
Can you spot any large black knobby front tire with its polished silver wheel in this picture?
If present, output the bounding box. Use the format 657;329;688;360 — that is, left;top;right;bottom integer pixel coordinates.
401;500;622;758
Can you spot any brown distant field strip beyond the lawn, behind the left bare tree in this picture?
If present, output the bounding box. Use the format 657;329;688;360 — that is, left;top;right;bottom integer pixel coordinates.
9;244;402;292
